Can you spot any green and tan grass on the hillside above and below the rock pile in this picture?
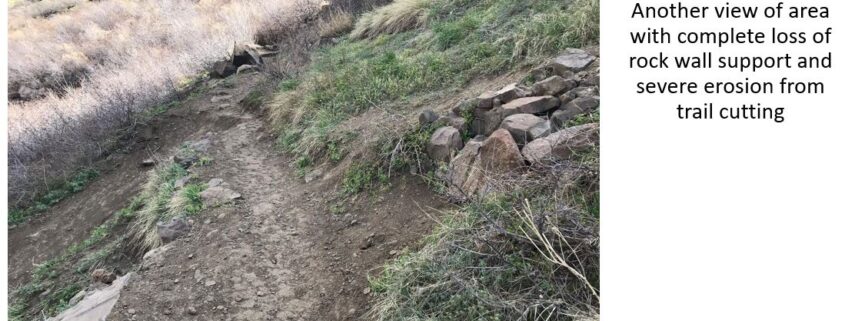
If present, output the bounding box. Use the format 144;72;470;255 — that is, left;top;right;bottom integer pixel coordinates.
269;0;599;320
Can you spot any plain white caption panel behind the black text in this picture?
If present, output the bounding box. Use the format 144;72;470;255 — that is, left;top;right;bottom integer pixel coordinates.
601;0;845;321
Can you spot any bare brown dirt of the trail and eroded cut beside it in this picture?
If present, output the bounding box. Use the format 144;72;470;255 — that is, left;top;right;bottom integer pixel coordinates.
9;74;450;320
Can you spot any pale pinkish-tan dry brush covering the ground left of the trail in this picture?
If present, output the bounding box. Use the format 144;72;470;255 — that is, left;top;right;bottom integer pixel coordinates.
8;0;319;204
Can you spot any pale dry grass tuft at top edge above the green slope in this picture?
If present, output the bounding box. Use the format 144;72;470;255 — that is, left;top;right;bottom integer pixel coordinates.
351;0;431;39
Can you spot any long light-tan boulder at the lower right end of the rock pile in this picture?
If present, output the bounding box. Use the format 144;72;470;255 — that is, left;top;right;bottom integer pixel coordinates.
522;123;599;165
